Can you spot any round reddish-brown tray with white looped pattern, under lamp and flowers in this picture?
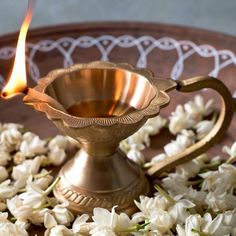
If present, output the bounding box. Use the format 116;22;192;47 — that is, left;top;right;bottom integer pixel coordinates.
0;22;236;235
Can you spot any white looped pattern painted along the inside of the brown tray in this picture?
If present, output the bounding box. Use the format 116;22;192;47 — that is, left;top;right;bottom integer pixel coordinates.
0;35;236;95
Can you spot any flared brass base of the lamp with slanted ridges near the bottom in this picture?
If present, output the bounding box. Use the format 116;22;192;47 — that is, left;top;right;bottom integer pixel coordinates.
54;149;150;215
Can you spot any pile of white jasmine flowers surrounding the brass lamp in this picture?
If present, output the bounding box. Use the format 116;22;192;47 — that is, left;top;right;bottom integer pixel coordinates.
0;96;236;236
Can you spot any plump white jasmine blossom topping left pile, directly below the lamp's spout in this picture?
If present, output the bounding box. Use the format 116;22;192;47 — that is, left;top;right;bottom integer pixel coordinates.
20;134;47;157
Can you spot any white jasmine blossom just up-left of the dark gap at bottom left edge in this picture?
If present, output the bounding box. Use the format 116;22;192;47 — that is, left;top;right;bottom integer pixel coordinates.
7;195;33;222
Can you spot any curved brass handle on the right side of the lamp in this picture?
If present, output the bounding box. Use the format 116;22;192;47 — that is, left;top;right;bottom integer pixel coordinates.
147;76;235;175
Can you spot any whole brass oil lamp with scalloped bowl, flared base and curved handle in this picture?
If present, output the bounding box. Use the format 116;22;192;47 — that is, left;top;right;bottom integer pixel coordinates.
24;61;233;214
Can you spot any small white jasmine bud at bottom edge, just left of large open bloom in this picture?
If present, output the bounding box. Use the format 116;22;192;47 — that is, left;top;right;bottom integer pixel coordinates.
72;214;91;234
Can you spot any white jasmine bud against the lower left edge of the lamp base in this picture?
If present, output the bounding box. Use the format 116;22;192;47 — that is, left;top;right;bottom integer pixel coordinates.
52;202;74;226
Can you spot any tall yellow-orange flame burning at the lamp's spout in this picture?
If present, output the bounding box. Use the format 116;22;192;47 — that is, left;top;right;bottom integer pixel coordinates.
1;0;34;98
